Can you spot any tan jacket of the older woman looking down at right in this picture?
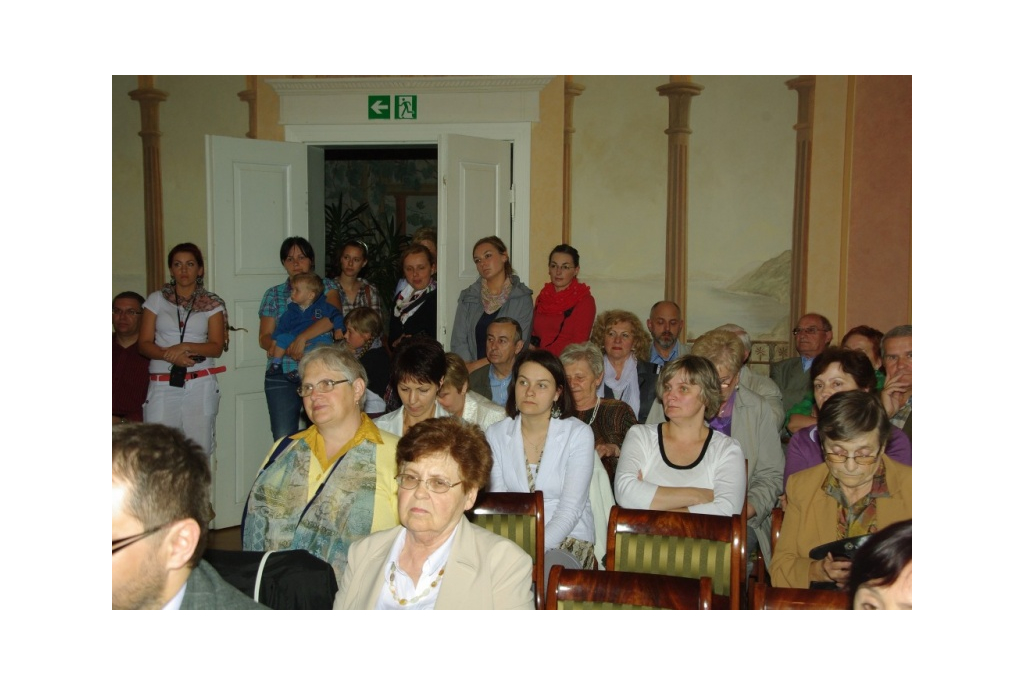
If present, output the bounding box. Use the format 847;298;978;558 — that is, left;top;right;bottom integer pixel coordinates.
768;455;913;588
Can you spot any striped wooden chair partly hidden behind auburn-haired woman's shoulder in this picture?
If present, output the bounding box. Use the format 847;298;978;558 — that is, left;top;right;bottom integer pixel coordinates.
466;490;544;609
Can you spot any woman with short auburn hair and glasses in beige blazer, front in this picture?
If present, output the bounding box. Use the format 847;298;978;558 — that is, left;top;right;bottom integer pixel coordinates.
334;417;534;609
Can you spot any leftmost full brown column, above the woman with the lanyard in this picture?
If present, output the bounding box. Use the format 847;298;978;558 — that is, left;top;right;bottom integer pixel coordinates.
128;76;167;293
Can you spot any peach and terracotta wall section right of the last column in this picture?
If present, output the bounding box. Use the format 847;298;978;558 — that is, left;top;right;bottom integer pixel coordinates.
807;76;912;339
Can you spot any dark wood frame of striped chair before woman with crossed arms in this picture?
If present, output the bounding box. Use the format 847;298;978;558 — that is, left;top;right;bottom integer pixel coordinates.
605;505;746;609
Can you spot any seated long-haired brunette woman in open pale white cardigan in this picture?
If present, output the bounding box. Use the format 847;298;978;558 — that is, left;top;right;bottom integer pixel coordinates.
486;350;595;568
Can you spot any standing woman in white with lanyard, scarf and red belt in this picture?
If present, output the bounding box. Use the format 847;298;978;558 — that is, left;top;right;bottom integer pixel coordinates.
138;243;227;455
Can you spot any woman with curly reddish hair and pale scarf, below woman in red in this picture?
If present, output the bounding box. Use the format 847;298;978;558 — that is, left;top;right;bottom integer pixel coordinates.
590;309;658;423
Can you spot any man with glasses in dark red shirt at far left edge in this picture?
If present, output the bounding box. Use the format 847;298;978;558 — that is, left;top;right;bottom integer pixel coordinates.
112;291;150;424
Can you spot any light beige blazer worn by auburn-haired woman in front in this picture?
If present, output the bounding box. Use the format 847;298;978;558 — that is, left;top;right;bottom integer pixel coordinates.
334;516;535;609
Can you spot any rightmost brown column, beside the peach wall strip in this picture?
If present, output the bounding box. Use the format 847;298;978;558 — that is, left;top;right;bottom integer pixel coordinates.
785;76;814;339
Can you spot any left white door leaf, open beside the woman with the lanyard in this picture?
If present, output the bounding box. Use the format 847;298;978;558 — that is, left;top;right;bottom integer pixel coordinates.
206;136;307;528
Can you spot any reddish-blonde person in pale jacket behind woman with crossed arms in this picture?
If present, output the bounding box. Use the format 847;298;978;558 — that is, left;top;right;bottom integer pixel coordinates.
690;330;785;561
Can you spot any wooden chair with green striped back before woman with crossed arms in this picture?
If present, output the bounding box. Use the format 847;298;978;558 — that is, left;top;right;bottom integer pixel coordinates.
606;506;746;609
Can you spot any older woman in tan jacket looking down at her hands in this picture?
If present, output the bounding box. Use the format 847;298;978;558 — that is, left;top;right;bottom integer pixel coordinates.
769;391;913;589
